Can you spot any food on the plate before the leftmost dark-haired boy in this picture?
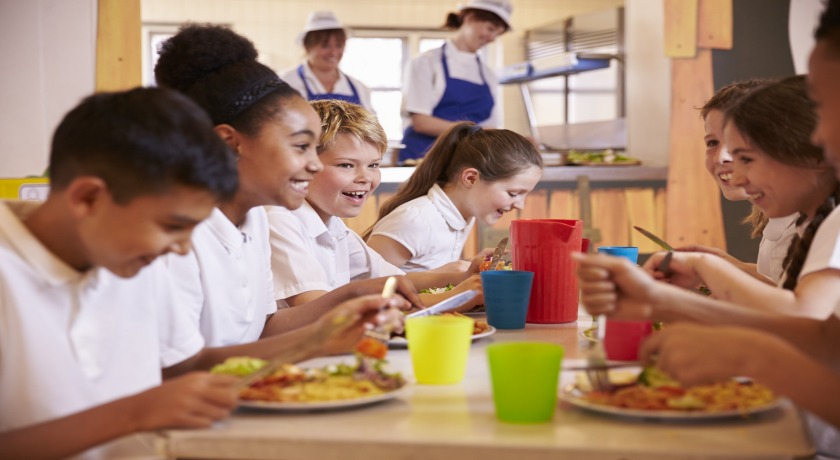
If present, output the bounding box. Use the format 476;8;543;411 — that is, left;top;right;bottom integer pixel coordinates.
212;358;408;411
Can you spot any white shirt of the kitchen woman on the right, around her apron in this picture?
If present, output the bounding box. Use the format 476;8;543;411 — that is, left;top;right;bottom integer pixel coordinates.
402;40;501;128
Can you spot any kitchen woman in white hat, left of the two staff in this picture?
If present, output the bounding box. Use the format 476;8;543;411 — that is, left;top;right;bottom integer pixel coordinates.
280;11;373;111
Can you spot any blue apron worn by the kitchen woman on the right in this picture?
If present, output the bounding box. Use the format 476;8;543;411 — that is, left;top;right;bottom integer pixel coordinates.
399;43;493;163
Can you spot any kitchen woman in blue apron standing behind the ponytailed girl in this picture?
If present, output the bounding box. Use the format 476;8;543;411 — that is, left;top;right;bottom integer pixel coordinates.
399;0;512;164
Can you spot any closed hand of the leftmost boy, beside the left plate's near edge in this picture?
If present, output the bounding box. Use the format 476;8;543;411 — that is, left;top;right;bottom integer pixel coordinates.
131;372;239;431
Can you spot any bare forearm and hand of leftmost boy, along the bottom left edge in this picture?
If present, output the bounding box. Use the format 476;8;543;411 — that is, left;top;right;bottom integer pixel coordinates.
0;373;239;459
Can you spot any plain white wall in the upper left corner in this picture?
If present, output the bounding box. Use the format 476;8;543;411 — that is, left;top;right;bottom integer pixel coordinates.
0;0;96;177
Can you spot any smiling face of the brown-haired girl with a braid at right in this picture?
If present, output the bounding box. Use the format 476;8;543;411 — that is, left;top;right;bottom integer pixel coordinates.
724;123;835;218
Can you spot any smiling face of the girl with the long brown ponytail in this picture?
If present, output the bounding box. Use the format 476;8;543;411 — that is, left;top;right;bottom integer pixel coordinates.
462;165;542;225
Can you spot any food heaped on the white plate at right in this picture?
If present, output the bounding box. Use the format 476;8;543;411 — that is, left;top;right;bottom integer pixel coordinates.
560;367;781;421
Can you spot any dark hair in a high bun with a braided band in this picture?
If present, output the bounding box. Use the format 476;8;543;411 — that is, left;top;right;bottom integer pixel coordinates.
155;24;300;135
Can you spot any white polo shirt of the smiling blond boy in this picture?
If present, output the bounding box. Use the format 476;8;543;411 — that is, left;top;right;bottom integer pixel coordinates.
267;202;405;299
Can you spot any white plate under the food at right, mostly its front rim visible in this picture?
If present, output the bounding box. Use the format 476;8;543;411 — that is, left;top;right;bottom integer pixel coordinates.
560;384;781;421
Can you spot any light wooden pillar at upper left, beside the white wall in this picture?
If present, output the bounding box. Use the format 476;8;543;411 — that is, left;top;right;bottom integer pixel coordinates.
96;0;143;91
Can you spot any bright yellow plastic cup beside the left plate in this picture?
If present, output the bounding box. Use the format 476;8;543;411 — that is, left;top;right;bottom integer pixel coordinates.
405;316;473;385
